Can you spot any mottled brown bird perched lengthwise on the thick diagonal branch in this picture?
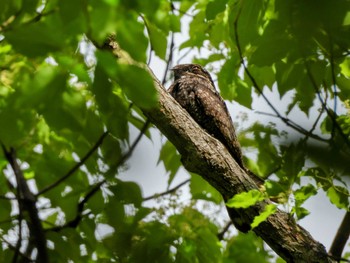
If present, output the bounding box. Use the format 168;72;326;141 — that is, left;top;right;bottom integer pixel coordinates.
168;64;263;233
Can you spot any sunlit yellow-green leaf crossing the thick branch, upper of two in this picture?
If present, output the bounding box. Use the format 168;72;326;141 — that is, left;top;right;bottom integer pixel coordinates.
226;189;265;208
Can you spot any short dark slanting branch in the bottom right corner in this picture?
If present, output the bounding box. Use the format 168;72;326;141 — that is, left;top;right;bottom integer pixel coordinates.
329;211;350;260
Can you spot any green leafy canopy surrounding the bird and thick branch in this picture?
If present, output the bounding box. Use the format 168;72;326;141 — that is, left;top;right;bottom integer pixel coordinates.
0;0;350;262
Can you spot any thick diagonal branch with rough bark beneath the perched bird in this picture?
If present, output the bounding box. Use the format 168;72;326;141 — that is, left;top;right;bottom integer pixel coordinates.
143;69;334;263
